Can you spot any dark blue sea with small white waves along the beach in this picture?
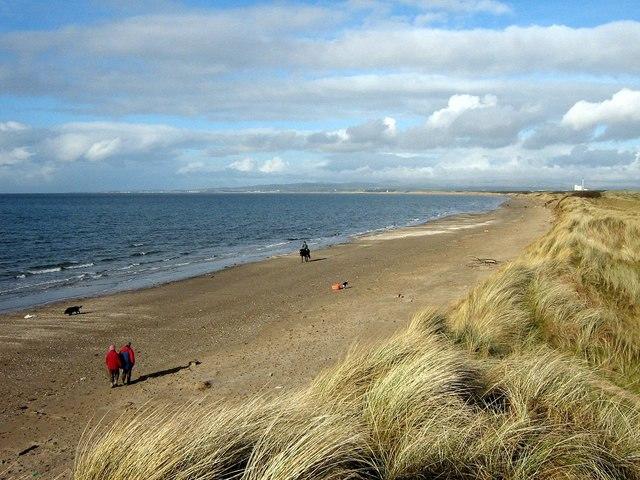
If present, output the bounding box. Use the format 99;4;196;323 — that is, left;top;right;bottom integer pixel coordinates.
0;194;503;311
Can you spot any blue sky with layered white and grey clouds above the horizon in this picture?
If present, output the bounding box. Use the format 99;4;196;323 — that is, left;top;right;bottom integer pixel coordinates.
0;0;640;193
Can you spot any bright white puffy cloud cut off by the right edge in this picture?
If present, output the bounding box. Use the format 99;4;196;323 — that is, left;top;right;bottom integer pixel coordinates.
562;88;640;129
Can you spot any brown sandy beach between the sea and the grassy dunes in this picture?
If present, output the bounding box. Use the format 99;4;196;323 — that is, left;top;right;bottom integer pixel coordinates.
0;194;550;478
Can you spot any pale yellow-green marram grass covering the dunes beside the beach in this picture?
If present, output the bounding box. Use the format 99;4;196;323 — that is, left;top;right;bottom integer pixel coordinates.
74;193;640;480
